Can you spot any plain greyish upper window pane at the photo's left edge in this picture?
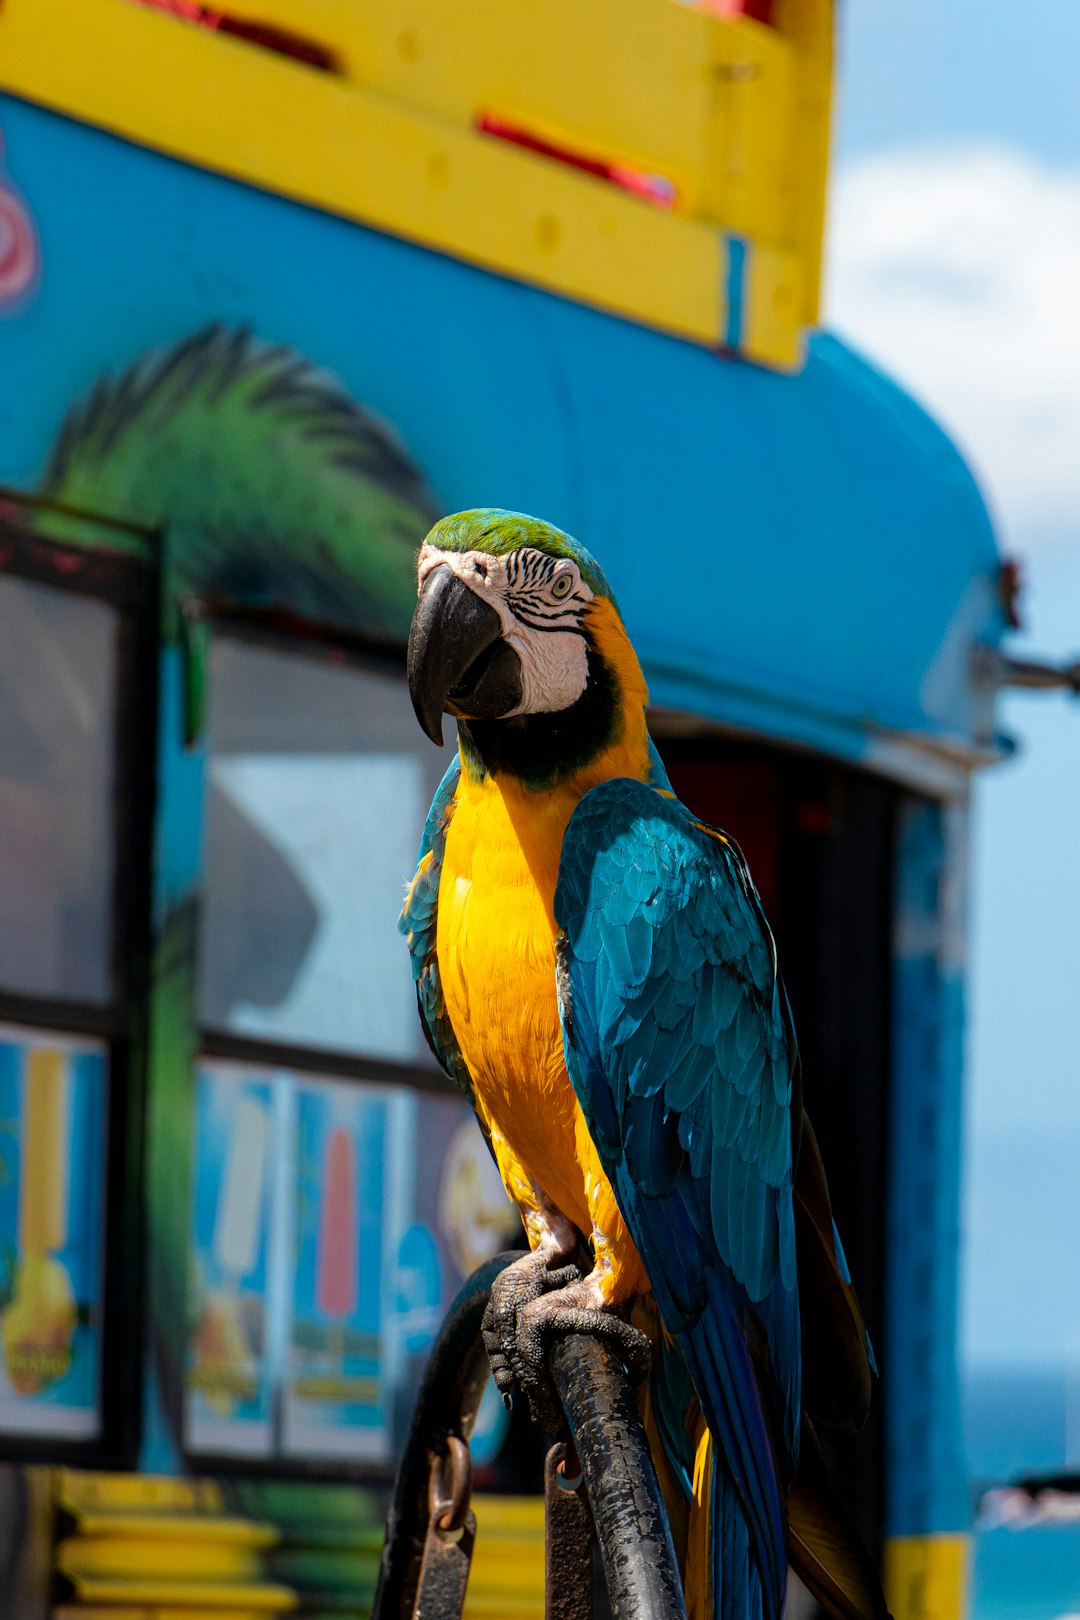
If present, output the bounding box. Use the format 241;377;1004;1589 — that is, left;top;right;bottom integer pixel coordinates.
0;575;118;1003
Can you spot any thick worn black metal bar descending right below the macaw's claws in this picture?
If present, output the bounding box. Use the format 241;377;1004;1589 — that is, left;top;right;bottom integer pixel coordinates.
547;1333;687;1620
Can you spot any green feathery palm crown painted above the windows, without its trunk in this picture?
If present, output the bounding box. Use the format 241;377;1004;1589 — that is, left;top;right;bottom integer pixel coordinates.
42;326;436;638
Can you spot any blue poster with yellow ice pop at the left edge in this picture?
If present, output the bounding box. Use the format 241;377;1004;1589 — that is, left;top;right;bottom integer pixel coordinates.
0;1029;107;1440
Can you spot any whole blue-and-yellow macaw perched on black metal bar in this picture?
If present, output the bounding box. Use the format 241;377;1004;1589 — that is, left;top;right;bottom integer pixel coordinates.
402;509;884;1620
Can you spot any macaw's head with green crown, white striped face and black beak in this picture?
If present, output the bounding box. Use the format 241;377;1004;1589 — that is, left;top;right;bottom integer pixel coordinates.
408;507;648;786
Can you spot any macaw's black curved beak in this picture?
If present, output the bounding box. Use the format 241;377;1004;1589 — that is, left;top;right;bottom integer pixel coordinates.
408;565;521;747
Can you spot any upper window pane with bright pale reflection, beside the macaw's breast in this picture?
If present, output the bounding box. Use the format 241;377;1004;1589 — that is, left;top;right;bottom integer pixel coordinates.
199;637;447;1063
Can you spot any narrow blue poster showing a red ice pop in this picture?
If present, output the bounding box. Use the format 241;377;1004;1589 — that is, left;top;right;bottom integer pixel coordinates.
282;1081;390;1461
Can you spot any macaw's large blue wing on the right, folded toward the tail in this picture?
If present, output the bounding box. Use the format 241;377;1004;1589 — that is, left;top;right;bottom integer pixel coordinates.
555;781;800;1617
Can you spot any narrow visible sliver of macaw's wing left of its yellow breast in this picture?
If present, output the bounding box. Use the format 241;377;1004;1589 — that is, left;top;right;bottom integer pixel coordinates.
398;753;473;1102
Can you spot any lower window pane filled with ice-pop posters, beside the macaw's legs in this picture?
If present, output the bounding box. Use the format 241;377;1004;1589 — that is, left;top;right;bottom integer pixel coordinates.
185;1059;518;1464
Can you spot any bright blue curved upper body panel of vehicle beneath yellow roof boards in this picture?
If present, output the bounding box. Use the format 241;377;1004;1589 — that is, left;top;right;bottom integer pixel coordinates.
0;99;1002;760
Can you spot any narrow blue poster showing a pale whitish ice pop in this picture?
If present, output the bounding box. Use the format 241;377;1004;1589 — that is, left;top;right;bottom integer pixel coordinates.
186;1063;275;1456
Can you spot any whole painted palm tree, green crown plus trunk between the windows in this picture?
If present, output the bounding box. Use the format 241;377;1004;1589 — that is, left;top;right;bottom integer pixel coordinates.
40;326;437;1464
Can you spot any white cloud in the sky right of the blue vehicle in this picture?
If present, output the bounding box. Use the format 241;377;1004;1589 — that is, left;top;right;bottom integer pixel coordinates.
826;146;1080;549
